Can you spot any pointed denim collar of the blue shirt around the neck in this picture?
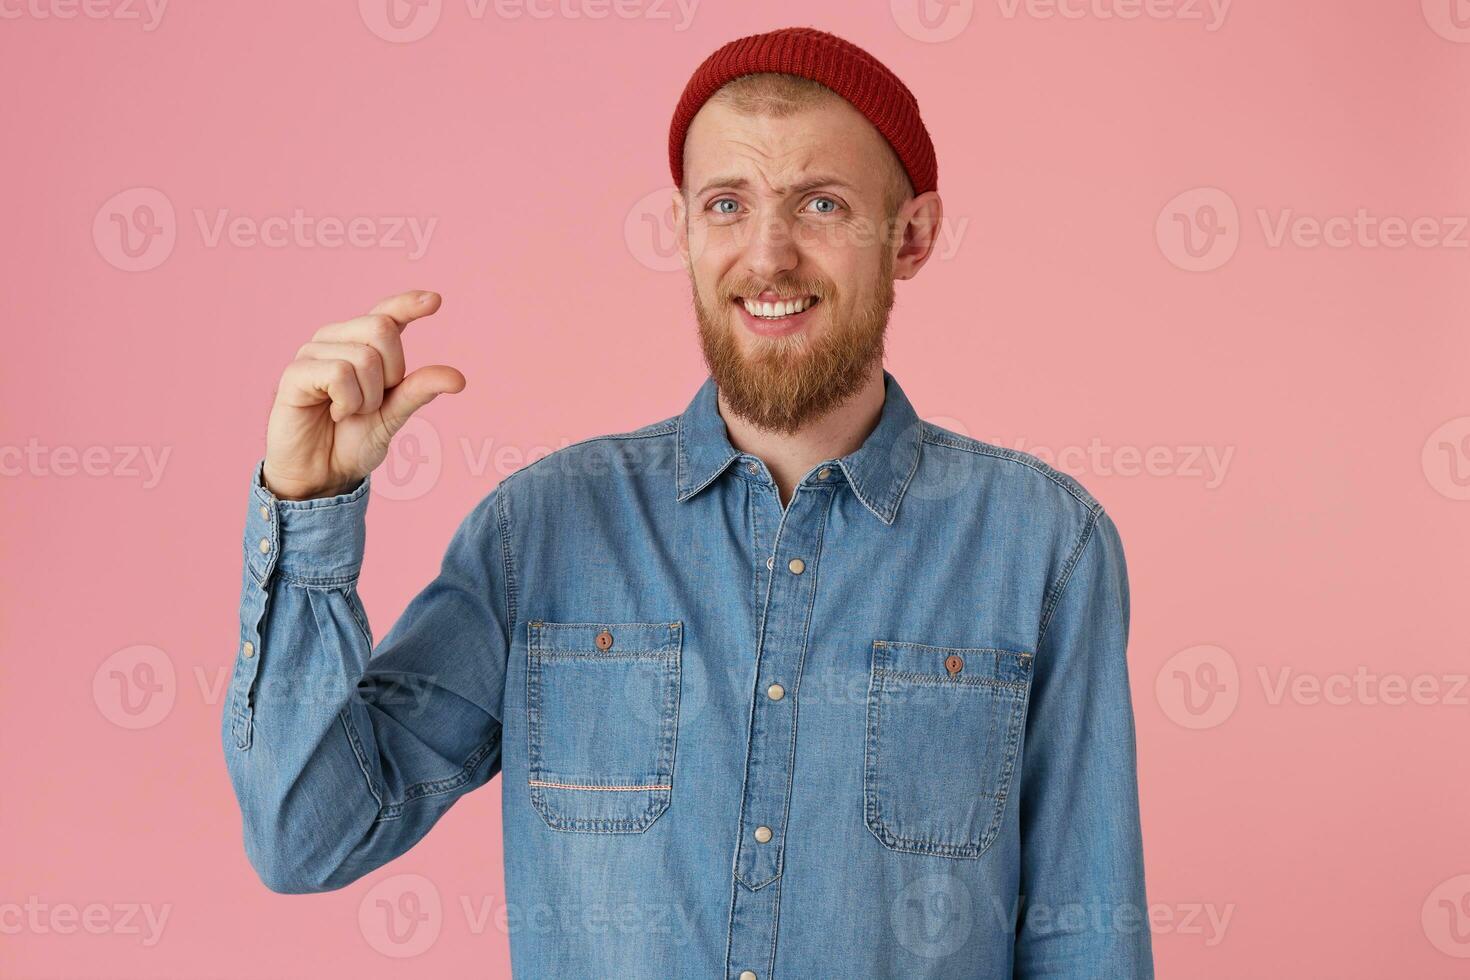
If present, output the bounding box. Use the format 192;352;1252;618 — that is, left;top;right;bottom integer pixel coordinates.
675;370;923;525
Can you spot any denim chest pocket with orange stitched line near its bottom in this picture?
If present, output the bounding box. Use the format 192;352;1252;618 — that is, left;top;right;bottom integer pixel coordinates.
526;621;684;833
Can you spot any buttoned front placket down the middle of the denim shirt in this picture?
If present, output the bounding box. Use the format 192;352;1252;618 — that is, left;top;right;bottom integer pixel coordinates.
726;466;833;980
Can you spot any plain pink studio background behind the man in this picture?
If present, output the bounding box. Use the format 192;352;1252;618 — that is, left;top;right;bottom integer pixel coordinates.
0;0;1470;979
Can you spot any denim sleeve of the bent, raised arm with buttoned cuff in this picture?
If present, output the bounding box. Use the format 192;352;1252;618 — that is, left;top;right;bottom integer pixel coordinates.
222;460;515;893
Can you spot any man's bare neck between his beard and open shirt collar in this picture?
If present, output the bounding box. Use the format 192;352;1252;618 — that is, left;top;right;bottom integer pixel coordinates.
717;360;885;507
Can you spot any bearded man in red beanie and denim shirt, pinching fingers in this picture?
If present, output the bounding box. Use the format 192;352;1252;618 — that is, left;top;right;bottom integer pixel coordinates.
222;28;1152;980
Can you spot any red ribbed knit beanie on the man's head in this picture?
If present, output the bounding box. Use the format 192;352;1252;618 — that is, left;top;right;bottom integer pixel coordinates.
669;28;939;194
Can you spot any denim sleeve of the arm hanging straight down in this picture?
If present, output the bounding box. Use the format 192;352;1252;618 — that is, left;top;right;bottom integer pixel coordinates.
1014;508;1154;980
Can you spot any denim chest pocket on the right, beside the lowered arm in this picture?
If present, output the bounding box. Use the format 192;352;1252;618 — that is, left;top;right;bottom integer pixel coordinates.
863;639;1032;858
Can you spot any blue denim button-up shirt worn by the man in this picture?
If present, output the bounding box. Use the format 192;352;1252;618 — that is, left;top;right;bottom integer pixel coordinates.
222;370;1152;980
